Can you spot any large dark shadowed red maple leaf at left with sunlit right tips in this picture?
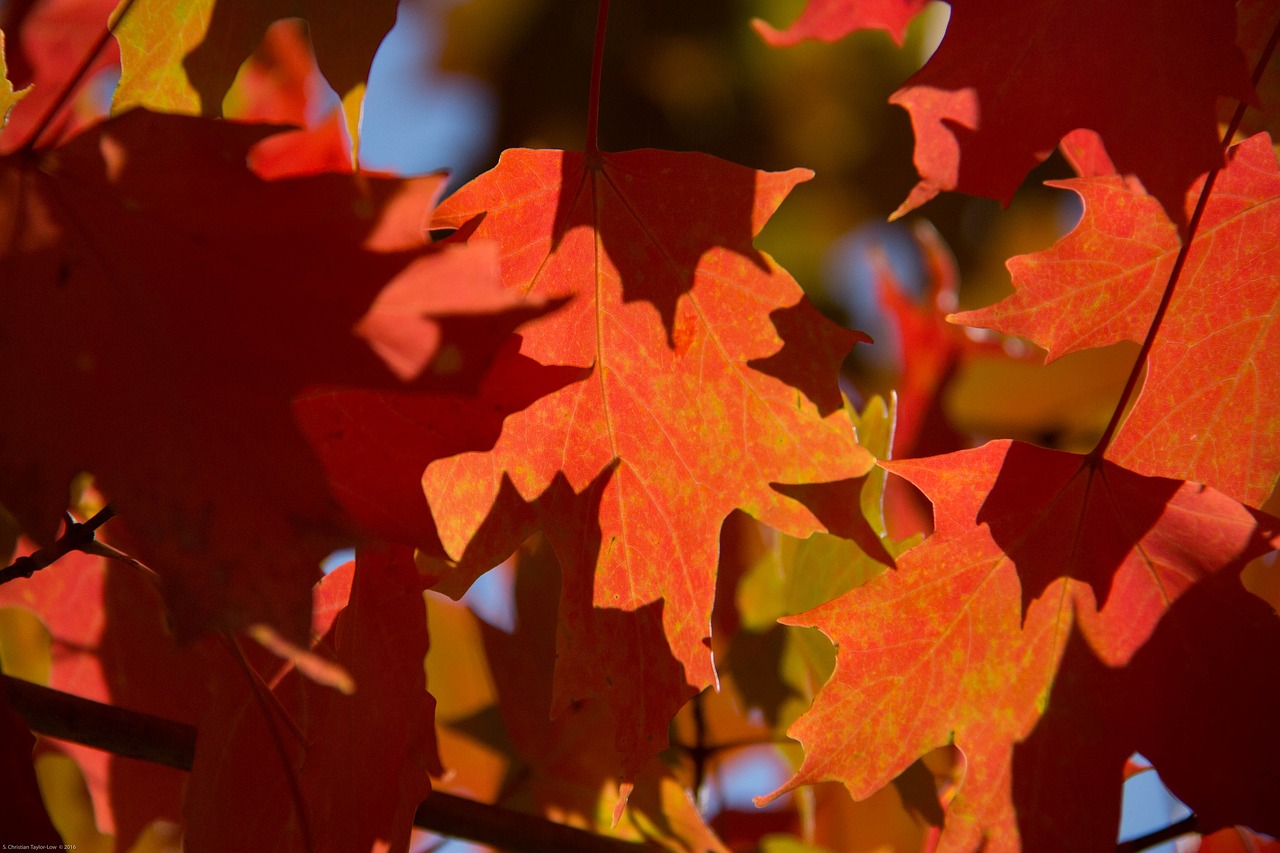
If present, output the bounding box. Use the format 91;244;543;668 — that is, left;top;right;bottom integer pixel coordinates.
0;110;550;639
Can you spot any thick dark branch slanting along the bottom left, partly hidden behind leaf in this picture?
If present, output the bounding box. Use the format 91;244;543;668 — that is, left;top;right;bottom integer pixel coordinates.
0;675;658;853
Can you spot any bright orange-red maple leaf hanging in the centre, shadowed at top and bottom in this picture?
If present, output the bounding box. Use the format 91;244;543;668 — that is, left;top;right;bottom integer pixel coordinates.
424;150;874;775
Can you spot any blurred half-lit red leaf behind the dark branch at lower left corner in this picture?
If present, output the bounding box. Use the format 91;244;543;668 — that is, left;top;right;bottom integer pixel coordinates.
0;543;211;849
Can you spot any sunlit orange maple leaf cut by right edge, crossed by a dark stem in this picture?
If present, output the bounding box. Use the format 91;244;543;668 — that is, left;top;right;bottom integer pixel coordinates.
951;134;1280;506
